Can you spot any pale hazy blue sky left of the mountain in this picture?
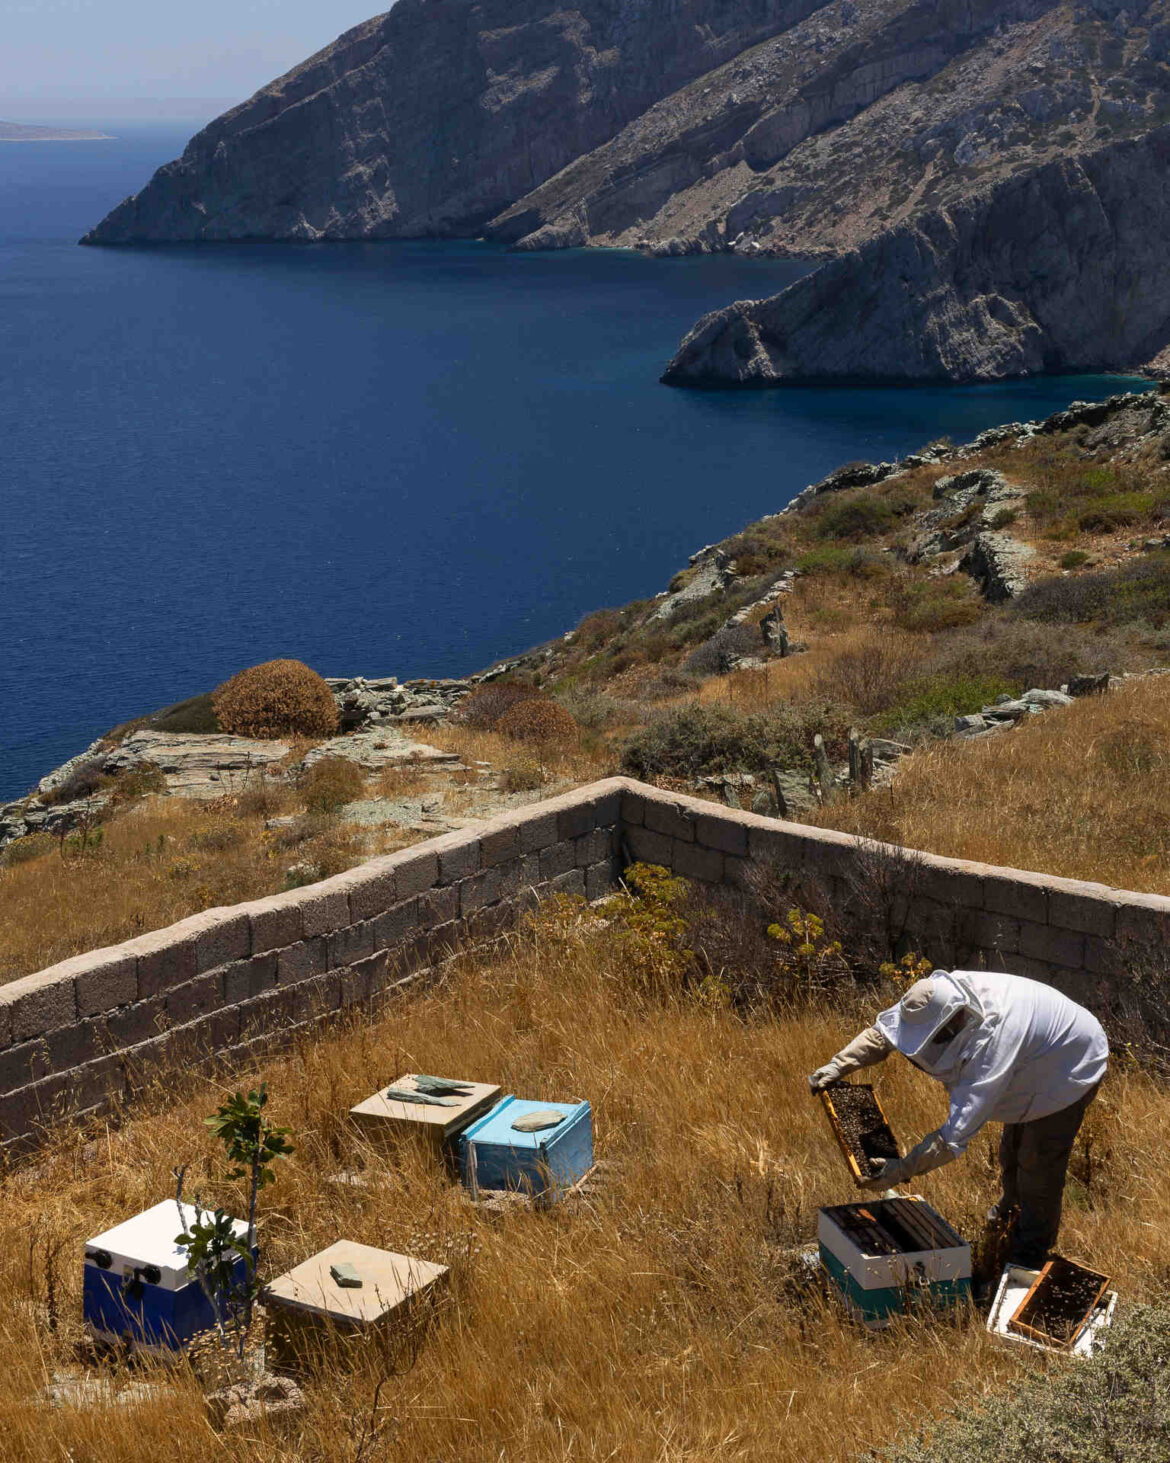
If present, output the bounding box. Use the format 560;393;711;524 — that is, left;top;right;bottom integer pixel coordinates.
0;0;390;119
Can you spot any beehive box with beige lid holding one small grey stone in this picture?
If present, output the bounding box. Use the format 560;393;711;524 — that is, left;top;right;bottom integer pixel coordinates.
265;1239;448;1371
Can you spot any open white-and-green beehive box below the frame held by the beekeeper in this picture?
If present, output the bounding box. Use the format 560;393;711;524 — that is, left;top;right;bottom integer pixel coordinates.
818;1195;971;1325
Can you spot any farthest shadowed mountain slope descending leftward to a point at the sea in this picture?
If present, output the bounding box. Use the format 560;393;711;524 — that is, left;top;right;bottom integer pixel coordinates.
85;0;815;243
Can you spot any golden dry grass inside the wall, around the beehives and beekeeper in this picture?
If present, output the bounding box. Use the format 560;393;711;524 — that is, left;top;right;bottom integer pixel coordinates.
0;912;1170;1463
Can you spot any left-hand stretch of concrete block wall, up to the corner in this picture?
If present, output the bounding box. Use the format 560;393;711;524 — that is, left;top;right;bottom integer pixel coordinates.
0;780;623;1151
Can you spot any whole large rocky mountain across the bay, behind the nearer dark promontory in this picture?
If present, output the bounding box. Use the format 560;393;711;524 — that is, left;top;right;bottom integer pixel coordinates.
86;0;1170;257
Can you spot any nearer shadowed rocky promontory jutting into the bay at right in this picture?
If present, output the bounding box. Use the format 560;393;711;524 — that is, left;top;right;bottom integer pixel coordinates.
663;127;1170;386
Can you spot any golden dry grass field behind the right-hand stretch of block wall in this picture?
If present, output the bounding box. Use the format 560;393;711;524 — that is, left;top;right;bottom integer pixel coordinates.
810;676;1170;894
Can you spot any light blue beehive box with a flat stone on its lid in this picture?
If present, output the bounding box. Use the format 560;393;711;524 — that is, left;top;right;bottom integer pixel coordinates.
459;1097;594;1197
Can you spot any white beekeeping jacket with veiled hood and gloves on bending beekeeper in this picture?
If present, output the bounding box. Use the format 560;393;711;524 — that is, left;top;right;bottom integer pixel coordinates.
812;970;1109;1185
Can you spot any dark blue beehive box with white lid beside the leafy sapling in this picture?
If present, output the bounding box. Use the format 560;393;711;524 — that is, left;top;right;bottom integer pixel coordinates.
82;1200;247;1350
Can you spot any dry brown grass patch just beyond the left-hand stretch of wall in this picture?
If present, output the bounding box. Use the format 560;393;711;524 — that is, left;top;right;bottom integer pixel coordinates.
0;789;418;982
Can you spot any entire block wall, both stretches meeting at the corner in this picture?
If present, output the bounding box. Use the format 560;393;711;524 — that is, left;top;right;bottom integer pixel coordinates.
0;778;1170;1147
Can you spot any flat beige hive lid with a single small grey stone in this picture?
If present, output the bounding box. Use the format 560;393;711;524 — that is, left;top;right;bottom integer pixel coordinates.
265;1239;448;1324
